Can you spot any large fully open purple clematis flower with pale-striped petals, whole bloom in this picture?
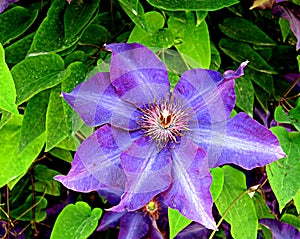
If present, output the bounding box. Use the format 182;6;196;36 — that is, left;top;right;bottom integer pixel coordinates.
55;43;285;229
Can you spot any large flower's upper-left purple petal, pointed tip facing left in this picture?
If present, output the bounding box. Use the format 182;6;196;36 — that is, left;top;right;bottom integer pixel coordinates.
63;72;138;129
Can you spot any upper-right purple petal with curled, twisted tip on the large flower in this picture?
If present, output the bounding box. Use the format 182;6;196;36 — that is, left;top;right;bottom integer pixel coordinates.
173;62;247;125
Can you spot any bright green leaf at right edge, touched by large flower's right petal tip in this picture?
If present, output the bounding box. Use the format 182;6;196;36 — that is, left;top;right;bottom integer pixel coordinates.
267;126;300;211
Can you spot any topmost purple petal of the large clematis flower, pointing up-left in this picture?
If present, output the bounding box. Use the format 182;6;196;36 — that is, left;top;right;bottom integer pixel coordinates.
106;43;170;106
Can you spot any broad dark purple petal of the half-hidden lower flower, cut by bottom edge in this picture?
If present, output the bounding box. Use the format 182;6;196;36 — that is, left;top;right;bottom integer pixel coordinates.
118;212;149;239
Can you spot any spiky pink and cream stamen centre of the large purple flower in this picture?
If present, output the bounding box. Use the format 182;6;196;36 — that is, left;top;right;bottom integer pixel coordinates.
137;98;190;147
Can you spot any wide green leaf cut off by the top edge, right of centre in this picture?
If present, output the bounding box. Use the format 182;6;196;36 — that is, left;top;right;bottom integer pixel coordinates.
147;0;239;11
